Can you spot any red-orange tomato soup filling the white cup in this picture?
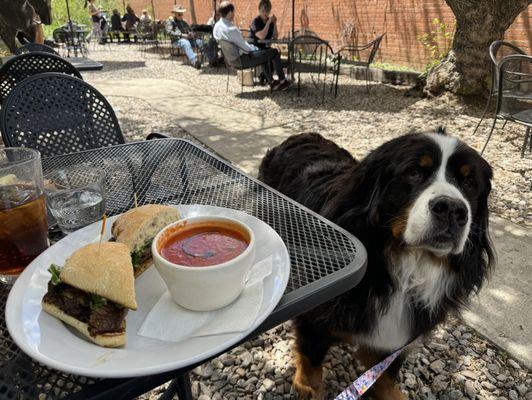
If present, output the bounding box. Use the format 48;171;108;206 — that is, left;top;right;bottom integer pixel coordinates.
159;224;249;267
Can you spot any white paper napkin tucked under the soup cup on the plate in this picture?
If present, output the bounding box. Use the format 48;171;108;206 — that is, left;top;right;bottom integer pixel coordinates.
137;256;273;342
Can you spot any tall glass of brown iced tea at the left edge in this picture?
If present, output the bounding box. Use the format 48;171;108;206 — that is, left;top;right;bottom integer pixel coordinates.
0;148;48;284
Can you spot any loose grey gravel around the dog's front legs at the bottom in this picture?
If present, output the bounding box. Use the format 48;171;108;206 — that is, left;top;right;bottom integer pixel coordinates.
135;318;532;400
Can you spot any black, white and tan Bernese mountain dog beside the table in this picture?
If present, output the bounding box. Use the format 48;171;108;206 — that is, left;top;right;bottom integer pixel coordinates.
259;128;494;400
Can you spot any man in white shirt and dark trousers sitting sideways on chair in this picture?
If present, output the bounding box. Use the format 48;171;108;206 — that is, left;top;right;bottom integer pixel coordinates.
213;1;290;90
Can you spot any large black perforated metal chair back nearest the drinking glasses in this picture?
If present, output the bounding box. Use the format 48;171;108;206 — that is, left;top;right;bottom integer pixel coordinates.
0;73;125;157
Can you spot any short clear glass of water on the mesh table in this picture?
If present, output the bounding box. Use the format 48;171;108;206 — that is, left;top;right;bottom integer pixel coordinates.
44;166;105;234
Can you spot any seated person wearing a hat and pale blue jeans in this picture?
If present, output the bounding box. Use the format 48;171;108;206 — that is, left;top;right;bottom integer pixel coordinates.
166;6;203;69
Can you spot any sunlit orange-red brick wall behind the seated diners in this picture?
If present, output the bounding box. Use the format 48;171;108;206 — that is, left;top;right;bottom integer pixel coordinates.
130;0;532;68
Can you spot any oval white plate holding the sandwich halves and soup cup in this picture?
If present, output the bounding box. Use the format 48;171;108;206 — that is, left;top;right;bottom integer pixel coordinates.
6;205;290;378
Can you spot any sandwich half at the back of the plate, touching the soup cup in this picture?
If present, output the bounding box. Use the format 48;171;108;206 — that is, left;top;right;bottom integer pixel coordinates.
111;204;179;278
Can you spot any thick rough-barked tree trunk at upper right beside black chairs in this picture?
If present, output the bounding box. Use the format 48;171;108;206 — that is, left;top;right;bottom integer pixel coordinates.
425;0;532;96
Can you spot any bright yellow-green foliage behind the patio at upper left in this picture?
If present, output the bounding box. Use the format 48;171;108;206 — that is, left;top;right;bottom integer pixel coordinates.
44;0;123;37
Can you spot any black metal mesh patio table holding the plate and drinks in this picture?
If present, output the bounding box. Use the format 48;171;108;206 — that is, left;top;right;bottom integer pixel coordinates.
0;139;366;400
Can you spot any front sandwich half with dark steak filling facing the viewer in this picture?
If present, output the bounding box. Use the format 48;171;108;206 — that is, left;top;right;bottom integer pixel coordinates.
42;242;137;347
